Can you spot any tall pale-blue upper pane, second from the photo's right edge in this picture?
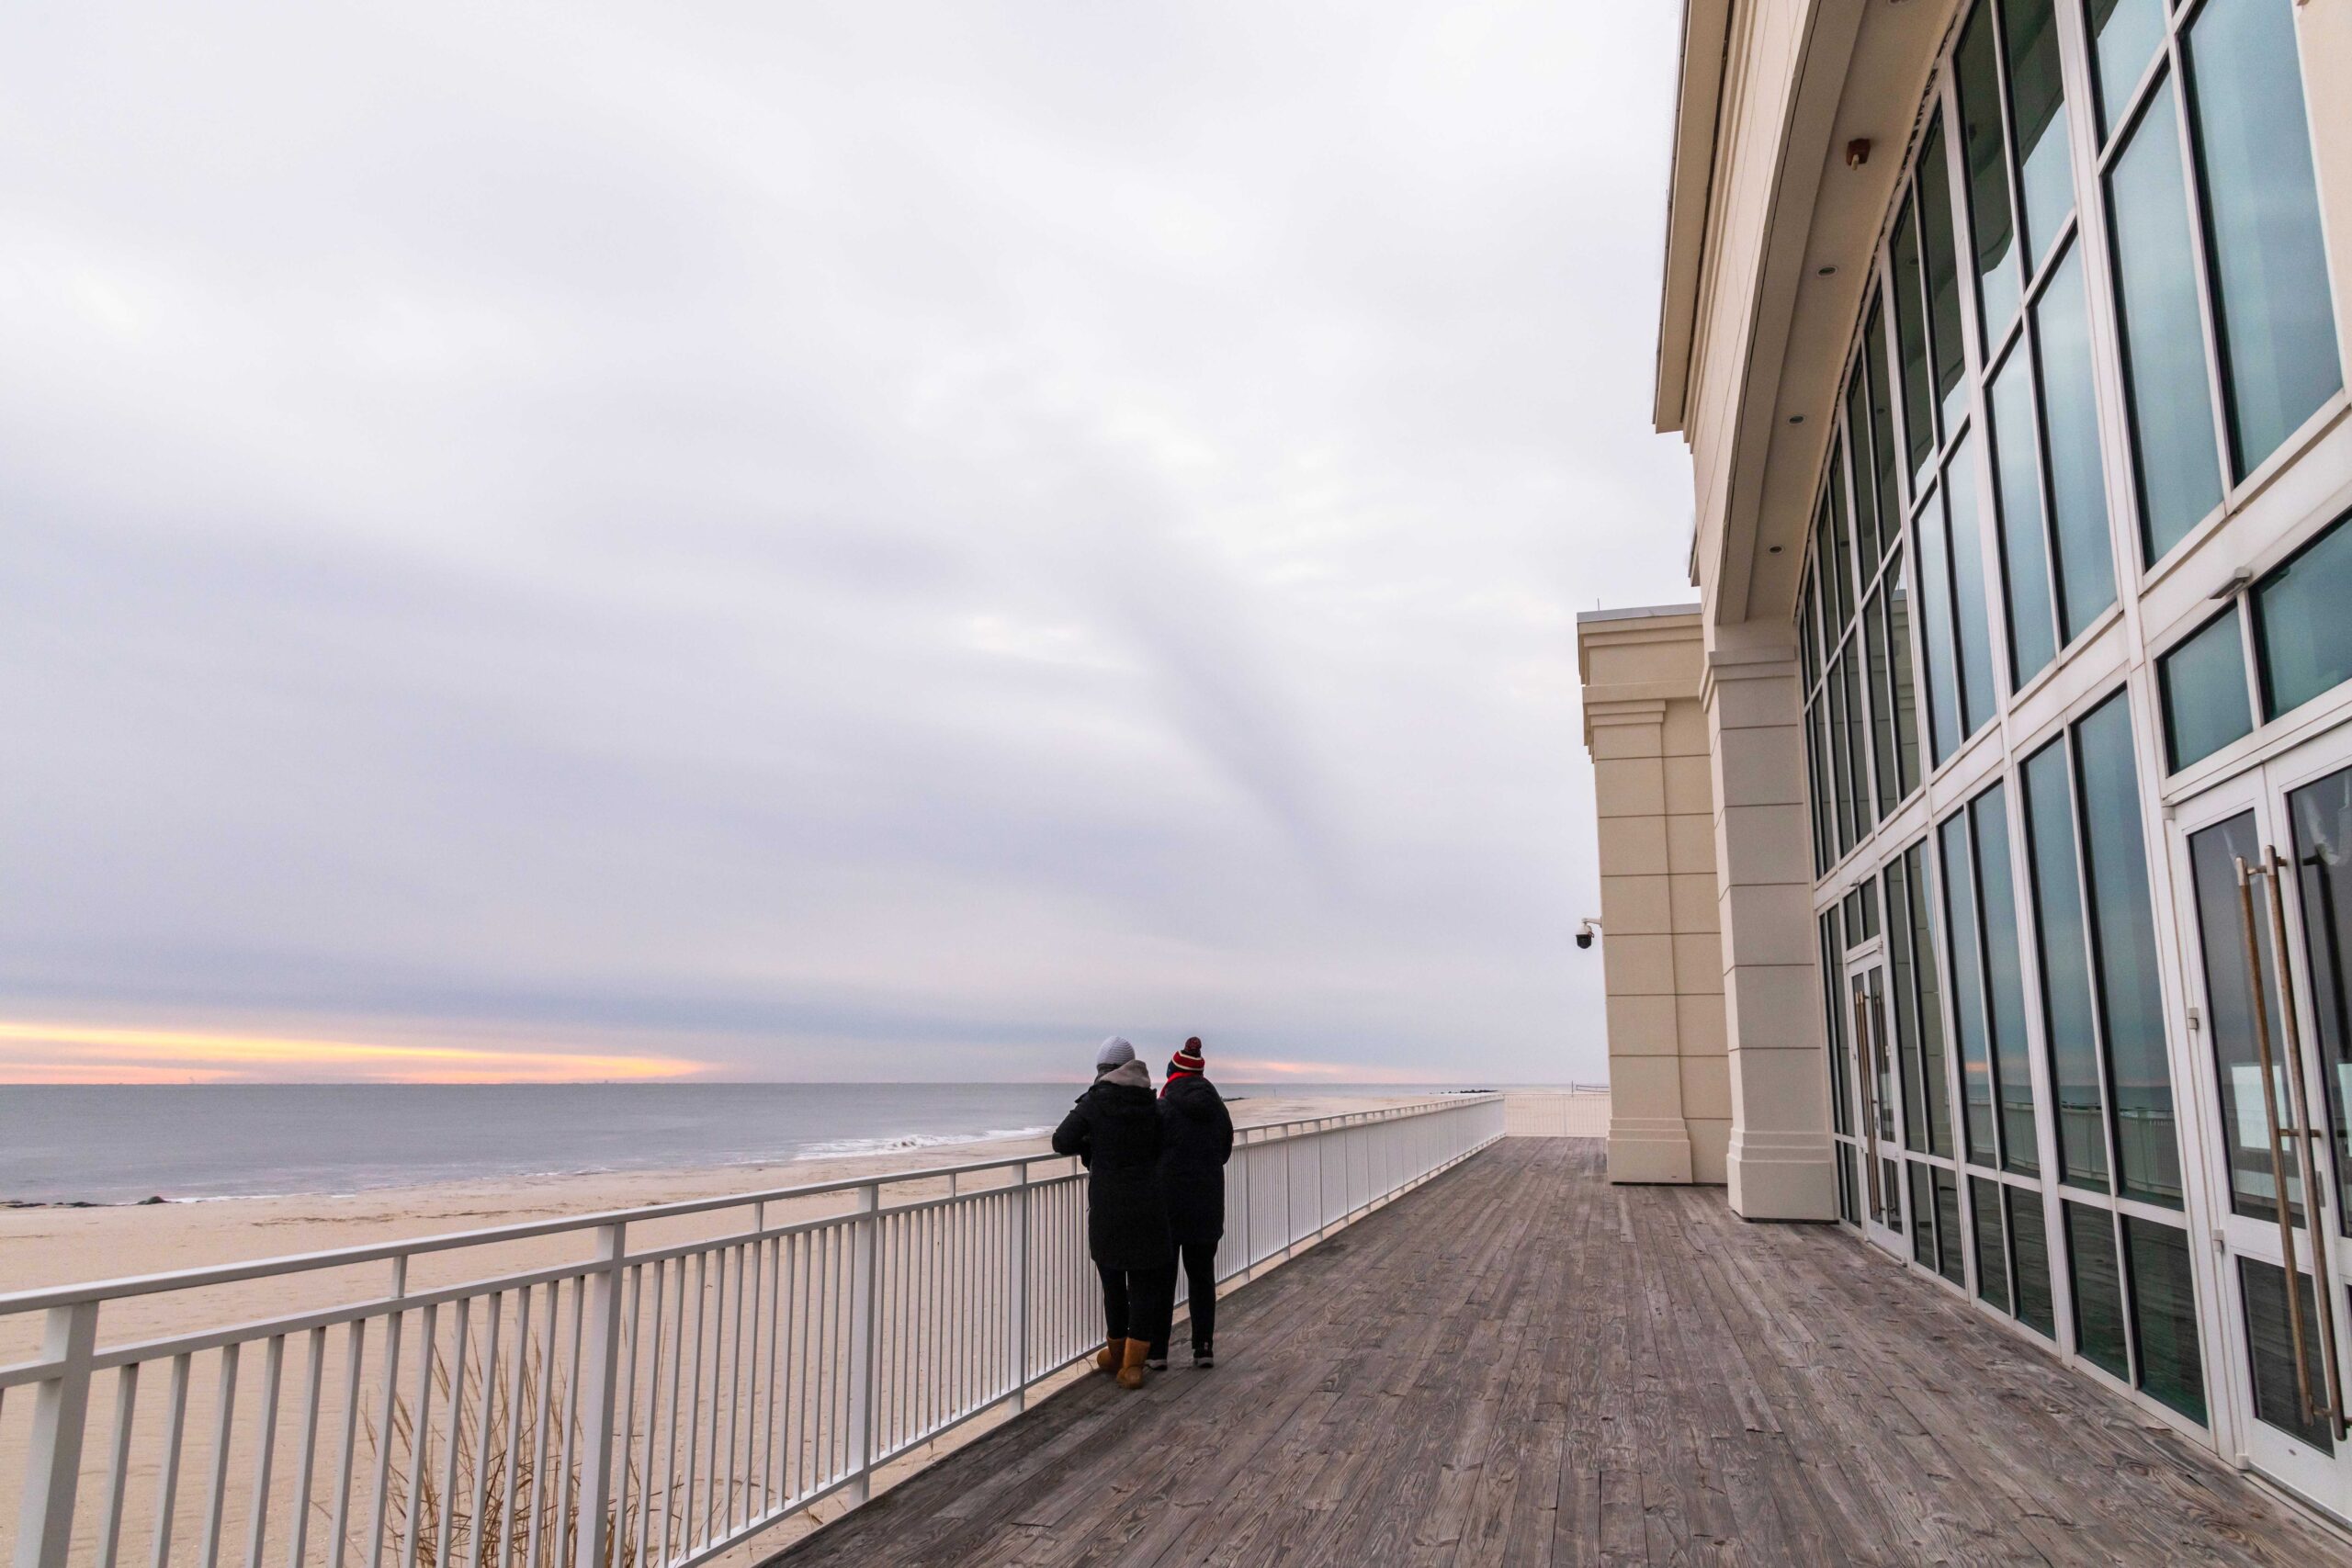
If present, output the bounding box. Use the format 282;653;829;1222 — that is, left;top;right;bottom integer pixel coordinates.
2108;92;2221;562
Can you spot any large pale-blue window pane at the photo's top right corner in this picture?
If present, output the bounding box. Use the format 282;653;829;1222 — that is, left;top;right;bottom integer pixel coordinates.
2188;0;2345;478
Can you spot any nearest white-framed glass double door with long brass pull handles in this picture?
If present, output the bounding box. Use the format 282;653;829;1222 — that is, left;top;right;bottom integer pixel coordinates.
2173;731;2352;1514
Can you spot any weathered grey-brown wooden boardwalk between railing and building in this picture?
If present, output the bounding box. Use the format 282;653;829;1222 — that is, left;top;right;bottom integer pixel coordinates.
776;1138;2352;1568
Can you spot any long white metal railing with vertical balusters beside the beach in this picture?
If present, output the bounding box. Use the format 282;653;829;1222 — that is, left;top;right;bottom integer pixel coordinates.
0;1096;1503;1568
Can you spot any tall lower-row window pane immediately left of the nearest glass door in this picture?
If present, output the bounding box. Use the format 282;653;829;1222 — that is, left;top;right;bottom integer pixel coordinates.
2075;691;2180;1208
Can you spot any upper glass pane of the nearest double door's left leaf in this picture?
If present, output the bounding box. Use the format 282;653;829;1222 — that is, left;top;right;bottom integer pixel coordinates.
2189;811;2302;1224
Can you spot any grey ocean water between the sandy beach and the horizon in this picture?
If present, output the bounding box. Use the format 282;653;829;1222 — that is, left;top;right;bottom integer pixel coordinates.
0;1081;1397;1203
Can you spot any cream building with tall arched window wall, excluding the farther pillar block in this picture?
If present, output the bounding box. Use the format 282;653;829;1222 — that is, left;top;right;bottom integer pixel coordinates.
1656;0;2352;1518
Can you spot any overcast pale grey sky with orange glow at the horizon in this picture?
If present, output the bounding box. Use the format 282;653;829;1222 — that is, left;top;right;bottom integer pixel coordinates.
0;0;1691;1081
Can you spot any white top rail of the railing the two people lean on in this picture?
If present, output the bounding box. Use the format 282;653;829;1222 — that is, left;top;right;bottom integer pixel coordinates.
0;1090;1500;1316
